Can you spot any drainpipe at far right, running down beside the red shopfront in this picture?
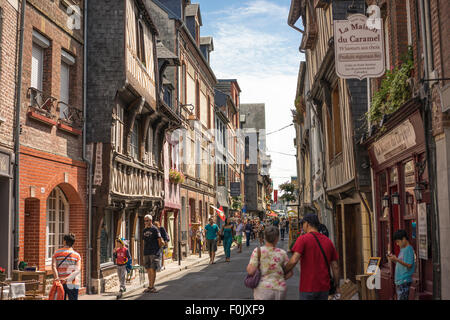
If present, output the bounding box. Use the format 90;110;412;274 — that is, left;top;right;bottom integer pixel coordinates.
419;0;441;300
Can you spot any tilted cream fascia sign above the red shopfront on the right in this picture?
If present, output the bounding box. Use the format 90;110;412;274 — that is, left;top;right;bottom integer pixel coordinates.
373;120;416;164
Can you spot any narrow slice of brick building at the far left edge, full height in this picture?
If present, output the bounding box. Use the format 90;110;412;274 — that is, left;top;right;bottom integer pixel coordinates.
0;0;19;273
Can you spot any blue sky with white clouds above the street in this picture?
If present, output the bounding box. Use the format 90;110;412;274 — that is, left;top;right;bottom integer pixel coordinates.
199;0;304;189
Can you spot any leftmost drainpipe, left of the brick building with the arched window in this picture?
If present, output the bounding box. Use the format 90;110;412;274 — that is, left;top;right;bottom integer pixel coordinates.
13;0;26;269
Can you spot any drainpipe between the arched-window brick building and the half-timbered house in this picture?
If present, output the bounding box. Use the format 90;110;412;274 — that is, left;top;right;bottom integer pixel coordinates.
83;0;92;294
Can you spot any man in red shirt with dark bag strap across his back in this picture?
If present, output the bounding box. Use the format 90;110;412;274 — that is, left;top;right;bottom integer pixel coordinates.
285;213;339;300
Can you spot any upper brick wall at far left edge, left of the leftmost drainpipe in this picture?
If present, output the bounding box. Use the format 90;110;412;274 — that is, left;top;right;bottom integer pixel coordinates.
0;0;18;148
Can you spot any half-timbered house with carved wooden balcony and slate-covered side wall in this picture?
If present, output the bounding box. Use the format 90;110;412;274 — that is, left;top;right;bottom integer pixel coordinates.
87;0;177;292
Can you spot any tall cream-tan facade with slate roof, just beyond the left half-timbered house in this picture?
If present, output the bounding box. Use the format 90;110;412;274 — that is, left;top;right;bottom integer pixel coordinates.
147;0;217;256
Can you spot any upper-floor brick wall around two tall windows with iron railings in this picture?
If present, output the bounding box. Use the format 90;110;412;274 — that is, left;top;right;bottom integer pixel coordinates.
20;1;84;161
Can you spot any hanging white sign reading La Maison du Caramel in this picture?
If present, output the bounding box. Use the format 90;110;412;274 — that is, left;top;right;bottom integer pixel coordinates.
334;13;386;80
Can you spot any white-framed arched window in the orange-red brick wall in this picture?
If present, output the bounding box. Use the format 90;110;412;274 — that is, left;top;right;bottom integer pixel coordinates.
45;187;70;266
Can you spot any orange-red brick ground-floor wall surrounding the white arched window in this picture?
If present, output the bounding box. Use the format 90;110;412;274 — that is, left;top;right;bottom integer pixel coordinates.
19;147;87;284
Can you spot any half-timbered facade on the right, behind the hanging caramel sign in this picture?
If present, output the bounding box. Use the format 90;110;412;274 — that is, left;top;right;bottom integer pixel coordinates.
288;1;373;281
